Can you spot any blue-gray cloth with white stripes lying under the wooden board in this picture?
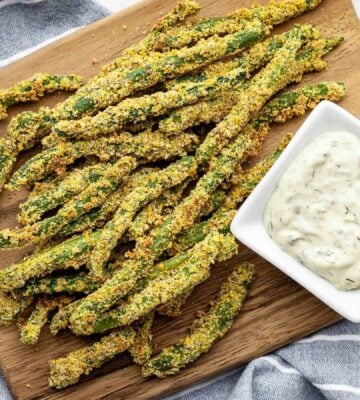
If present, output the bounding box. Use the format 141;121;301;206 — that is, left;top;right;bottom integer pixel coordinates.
0;0;360;400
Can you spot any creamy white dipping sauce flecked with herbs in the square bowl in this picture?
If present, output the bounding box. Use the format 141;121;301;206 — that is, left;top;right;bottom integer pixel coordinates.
264;132;360;290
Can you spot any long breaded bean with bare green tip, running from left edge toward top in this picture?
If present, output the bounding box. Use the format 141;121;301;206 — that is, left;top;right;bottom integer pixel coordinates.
0;16;265;194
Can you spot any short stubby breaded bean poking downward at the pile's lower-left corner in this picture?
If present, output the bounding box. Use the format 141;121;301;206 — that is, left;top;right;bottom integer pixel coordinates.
19;296;73;345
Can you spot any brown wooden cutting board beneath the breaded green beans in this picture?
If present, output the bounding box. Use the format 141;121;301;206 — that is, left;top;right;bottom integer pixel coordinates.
0;0;360;400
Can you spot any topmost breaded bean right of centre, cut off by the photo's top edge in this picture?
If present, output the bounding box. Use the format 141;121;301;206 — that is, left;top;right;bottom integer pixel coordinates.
155;0;321;50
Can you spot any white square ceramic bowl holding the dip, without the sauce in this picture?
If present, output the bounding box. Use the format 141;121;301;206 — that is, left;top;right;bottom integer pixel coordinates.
231;101;360;322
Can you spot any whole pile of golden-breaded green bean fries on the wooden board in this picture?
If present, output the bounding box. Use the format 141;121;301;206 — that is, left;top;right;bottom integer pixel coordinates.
0;0;346;389
